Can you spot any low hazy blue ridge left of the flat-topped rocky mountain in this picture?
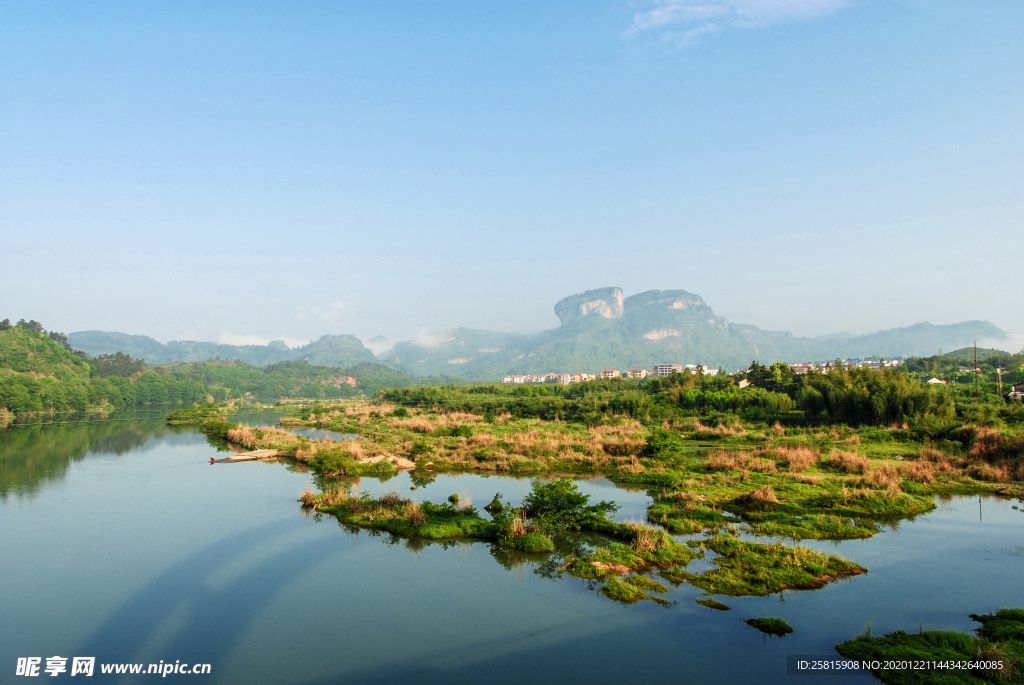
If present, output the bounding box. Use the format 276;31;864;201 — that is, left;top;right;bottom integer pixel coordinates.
68;331;377;367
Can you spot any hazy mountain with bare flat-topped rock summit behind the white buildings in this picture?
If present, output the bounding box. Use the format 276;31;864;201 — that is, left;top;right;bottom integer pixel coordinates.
381;288;1007;379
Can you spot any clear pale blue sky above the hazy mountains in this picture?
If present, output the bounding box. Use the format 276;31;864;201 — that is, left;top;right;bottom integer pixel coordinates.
0;0;1024;344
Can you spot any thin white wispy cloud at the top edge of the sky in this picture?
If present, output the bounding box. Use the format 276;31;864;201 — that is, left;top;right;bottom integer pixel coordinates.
628;0;852;44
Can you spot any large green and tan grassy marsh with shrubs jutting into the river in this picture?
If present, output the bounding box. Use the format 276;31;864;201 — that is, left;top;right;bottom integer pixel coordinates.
157;363;1024;608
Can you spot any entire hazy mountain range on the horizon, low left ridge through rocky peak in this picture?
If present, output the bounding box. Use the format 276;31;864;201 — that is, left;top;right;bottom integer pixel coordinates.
69;287;1008;379
